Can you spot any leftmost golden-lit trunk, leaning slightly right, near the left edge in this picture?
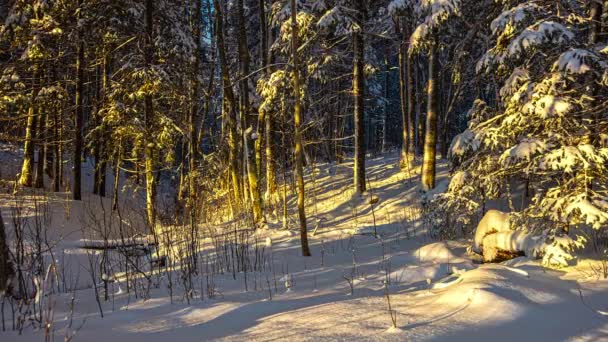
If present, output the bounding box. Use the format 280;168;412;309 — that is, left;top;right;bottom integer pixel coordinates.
19;65;40;187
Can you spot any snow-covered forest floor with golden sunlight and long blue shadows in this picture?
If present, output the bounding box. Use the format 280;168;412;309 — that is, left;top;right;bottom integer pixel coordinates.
0;148;608;342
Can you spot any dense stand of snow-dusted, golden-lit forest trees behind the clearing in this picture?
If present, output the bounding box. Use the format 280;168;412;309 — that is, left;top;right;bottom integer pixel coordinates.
0;0;608;264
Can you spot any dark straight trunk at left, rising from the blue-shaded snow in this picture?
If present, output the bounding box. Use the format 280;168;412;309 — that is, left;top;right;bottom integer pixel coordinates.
72;4;84;201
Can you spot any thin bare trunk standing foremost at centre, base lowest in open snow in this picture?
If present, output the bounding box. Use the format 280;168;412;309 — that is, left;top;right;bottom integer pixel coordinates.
291;0;310;256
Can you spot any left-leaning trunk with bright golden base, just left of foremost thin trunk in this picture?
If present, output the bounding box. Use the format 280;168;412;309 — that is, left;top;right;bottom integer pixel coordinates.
237;0;264;223
